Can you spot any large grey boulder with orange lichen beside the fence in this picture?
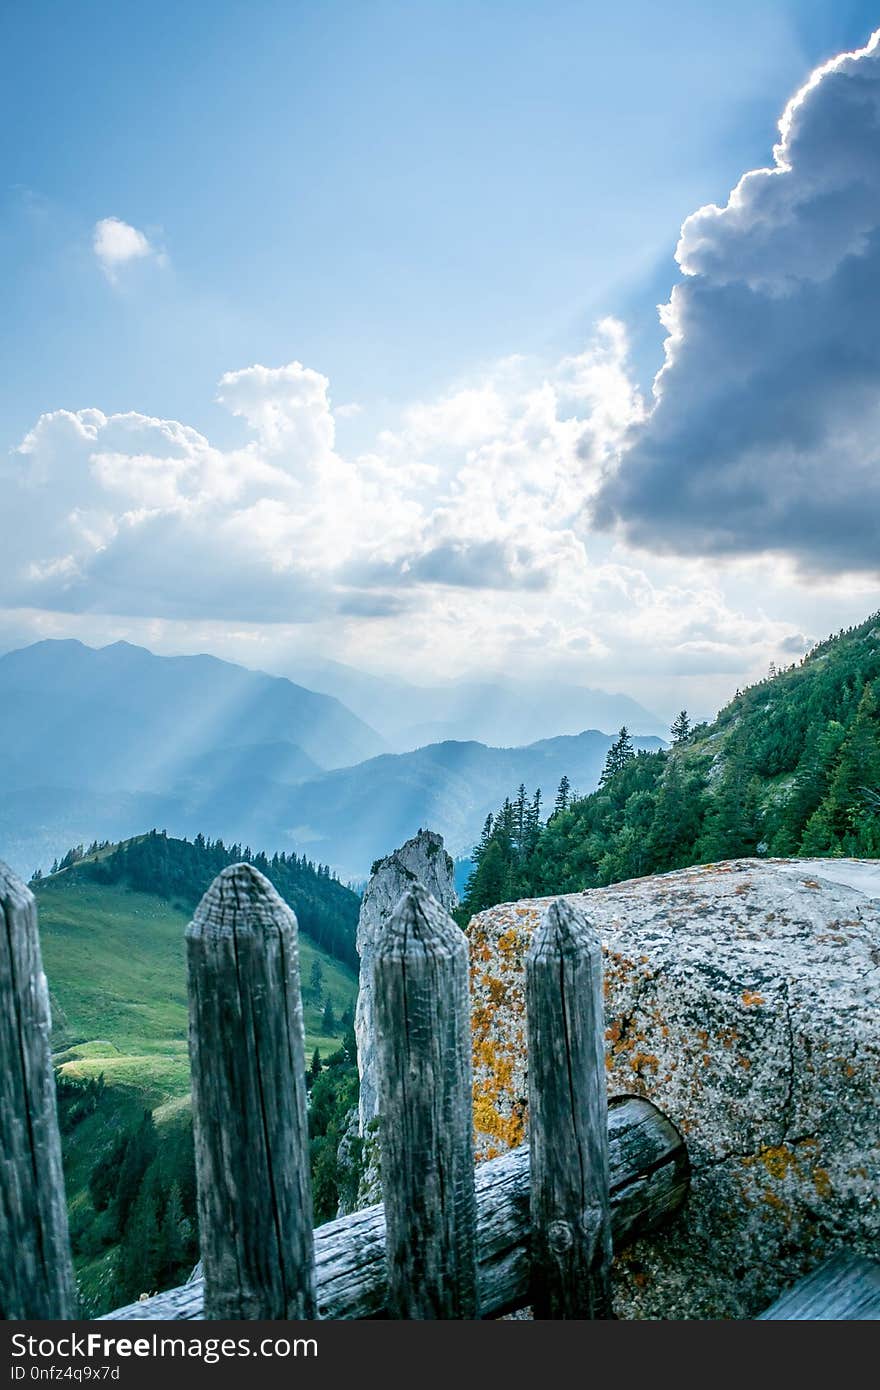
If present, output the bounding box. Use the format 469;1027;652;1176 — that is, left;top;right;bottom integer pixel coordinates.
468;860;880;1318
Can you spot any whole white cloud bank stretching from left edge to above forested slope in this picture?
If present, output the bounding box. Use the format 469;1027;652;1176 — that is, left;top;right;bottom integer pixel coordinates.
0;321;823;705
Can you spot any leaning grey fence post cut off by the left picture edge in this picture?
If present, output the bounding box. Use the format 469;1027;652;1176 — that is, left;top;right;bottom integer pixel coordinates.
0;863;76;1321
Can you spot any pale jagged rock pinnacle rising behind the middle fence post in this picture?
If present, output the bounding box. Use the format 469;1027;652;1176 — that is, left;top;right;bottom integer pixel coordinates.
355;830;459;1136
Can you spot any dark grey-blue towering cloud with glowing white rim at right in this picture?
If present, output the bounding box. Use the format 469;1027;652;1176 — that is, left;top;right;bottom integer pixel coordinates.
594;31;880;573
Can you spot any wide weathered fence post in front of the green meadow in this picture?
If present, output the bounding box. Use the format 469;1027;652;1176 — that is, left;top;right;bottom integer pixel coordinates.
186;863;316;1319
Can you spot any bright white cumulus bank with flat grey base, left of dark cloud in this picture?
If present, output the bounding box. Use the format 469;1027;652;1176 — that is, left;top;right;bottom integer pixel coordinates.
0;321;641;621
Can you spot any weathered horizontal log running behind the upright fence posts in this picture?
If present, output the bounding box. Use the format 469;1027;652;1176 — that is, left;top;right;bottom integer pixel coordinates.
106;1097;690;1321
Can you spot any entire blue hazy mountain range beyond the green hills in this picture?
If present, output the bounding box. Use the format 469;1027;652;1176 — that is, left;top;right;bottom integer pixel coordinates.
0;641;660;878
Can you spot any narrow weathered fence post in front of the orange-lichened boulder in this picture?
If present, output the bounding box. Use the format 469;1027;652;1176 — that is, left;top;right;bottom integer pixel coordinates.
525;898;612;1318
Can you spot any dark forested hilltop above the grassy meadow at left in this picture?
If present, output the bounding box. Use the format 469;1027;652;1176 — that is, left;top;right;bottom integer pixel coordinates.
35;830;360;970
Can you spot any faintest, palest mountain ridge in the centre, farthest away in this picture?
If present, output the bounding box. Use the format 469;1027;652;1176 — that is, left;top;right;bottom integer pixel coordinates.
284;662;667;752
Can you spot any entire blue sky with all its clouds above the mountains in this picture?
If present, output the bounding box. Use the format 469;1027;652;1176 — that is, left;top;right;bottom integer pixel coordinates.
0;0;880;714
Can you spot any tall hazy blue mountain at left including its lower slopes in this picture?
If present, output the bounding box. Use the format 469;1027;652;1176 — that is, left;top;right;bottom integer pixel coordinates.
0;641;386;869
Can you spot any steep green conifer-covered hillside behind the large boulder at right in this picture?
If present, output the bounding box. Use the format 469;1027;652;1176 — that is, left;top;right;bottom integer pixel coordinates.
460;614;880;919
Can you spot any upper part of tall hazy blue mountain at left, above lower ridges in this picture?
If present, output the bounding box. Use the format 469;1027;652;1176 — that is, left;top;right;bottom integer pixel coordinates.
0;641;386;791
